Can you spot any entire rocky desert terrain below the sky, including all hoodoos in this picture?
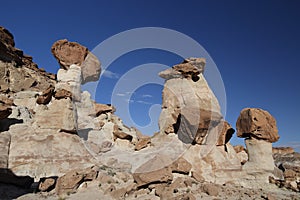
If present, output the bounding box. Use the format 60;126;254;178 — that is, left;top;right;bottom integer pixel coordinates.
0;27;300;199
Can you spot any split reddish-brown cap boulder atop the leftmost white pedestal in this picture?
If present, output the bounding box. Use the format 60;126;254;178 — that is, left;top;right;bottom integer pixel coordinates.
51;39;101;84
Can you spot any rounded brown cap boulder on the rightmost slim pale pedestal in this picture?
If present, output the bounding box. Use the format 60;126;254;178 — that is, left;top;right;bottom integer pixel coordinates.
236;108;279;143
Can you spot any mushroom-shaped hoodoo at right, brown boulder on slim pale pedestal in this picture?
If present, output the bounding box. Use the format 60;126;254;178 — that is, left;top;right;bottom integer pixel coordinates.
236;108;282;185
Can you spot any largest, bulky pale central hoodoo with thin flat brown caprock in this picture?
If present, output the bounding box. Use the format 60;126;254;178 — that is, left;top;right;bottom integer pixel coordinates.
159;58;222;144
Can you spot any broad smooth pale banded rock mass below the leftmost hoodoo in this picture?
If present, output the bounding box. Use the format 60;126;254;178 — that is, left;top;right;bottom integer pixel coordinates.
8;124;94;180
